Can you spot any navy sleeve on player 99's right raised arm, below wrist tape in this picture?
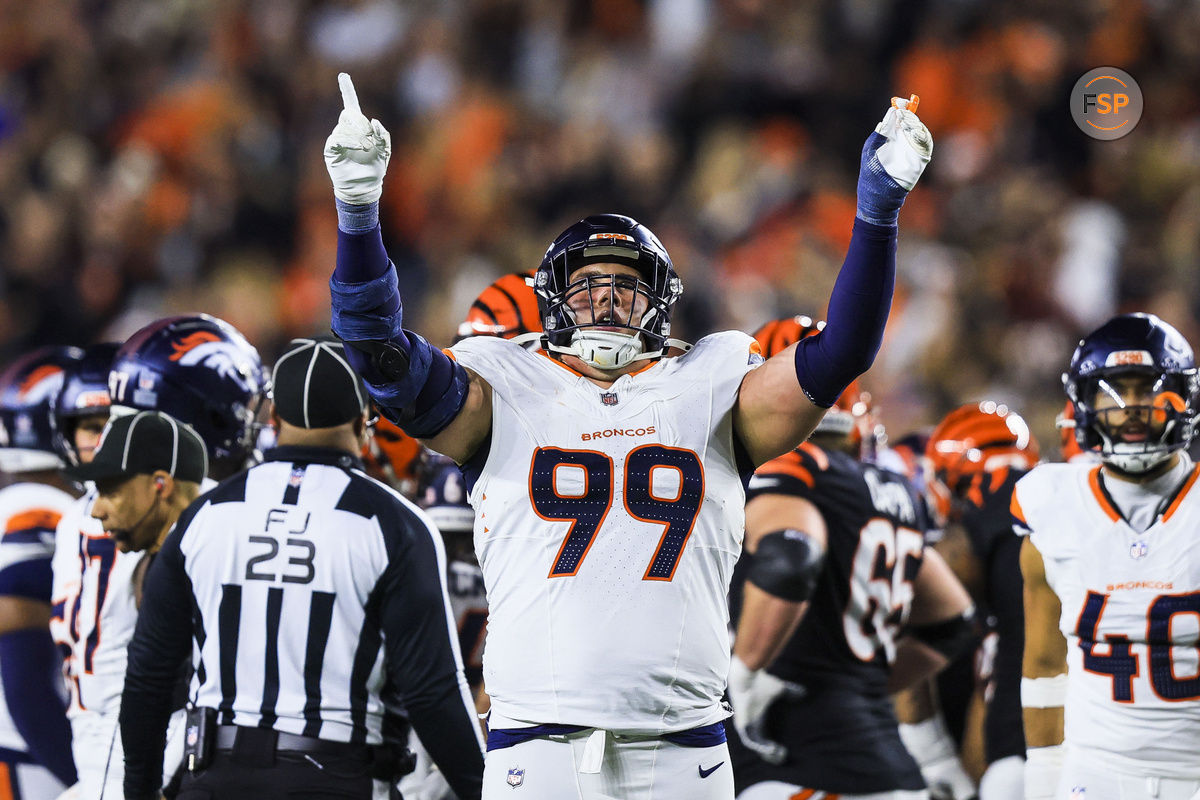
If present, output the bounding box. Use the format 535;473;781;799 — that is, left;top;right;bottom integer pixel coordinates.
796;219;896;408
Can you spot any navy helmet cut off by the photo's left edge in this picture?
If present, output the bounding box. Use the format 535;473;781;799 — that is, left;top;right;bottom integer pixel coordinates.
0;347;83;473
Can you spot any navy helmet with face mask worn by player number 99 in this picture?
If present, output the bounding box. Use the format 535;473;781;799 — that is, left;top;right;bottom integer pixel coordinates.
534;213;683;369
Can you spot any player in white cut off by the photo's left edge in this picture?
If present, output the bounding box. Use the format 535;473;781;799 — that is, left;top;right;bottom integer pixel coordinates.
0;348;83;800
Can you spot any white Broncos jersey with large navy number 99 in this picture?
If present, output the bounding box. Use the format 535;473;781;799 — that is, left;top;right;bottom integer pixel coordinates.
452;332;762;734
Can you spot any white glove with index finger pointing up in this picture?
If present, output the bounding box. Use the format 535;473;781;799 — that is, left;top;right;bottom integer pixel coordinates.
325;72;391;205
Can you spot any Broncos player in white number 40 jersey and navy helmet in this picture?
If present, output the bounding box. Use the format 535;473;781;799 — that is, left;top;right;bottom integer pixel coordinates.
1012;314;1200;800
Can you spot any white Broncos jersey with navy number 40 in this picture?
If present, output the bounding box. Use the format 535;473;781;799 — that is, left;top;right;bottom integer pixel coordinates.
1013;464;1200;778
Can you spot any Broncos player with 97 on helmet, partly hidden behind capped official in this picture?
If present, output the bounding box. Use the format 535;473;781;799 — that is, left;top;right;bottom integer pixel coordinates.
50;314;266;800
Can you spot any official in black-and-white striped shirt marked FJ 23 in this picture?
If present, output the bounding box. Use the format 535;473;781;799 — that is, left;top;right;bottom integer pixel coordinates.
121;339;484;800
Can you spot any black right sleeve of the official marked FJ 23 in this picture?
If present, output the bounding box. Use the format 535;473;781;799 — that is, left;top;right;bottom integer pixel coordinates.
373;510;484;800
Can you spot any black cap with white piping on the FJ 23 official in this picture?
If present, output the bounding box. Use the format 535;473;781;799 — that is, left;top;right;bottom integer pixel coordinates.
272;337;368;428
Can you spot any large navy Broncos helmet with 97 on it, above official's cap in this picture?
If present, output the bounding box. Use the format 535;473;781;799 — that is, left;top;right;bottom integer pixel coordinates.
108;314;269;474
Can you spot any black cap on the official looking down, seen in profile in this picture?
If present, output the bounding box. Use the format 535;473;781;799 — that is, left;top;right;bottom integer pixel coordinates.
64;411;209;483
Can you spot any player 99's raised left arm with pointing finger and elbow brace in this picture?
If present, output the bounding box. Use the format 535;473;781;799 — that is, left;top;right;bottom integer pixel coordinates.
325;72;492;463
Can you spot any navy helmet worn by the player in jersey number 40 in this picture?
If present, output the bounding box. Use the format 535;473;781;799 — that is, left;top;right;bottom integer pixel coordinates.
1062;313;1200;474
